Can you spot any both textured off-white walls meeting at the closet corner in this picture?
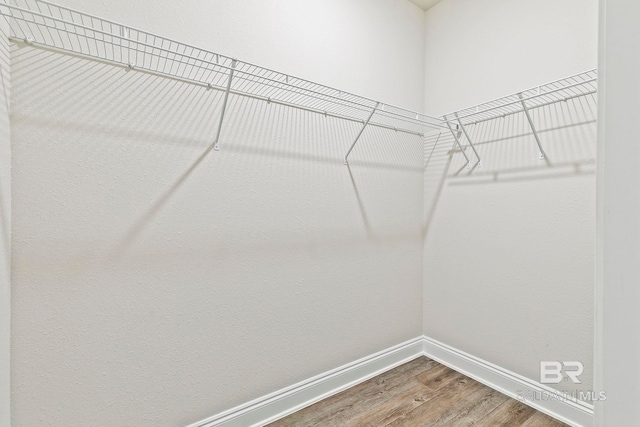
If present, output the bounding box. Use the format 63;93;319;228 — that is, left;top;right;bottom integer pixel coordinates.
7;0;597;426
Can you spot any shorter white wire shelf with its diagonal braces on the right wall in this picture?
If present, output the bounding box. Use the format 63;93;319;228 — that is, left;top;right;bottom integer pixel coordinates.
442;69;598;168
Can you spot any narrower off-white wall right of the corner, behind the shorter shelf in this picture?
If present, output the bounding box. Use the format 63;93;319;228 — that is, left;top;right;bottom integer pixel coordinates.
424;0;598;398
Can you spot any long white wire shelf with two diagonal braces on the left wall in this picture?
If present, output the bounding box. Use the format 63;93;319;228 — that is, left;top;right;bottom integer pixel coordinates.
0;0;446;163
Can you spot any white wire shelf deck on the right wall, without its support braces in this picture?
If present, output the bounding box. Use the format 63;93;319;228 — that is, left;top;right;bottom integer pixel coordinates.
443;69;598;125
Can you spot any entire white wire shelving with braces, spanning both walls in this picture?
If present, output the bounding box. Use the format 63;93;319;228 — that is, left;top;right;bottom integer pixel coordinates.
0;0;597;167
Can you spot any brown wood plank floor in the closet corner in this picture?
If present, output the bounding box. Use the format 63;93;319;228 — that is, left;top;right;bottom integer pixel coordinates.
269;357;566;427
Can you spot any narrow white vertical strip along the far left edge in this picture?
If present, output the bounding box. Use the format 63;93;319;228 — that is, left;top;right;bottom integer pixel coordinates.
0;15;11;427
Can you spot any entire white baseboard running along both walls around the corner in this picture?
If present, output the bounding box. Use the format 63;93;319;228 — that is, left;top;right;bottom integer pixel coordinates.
188;336;593;427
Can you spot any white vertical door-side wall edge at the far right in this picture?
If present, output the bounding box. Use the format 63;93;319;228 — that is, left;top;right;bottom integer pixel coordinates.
595;0;640;427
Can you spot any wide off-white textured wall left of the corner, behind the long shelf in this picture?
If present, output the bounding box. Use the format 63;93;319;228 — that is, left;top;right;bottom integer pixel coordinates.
11;0;424;427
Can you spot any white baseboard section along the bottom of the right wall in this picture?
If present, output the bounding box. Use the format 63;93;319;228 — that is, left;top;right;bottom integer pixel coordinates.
423;336;593;427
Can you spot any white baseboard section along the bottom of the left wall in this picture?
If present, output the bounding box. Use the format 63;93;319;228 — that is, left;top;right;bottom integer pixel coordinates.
188;337;423;427
